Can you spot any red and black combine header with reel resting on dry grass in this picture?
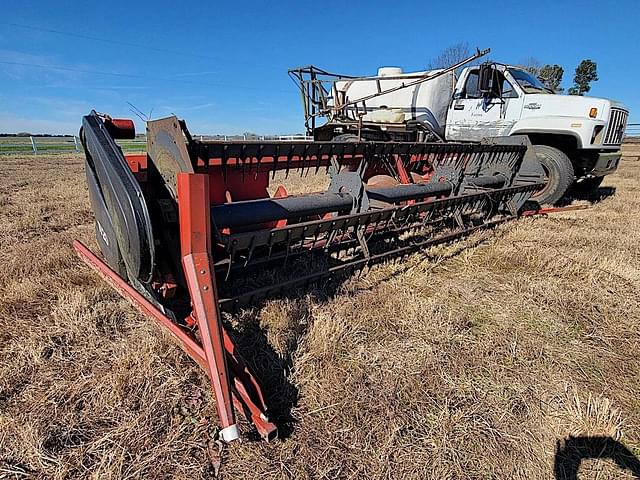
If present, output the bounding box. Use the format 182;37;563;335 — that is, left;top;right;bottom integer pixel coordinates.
75;112;543;441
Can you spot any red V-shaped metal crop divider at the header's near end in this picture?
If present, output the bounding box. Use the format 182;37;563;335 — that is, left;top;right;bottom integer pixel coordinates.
73;173;278;442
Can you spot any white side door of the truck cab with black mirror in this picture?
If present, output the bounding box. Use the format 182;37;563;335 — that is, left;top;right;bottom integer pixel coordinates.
446;68;522;142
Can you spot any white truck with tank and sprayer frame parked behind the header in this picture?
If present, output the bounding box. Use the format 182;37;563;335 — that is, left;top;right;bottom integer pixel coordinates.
290;59;629;204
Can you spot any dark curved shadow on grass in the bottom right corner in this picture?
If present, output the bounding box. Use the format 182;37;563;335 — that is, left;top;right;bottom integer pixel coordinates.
554;437;640;480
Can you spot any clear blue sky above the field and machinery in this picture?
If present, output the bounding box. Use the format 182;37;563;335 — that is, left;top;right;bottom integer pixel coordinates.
0;0;640;134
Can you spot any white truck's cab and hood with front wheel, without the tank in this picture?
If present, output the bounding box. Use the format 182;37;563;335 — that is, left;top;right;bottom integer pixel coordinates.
445;63;628;203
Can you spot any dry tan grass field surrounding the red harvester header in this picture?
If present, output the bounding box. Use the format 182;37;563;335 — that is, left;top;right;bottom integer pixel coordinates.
0;145;640;479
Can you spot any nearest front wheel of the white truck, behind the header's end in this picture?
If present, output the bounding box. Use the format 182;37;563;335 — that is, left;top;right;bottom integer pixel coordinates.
531;145;574;205
